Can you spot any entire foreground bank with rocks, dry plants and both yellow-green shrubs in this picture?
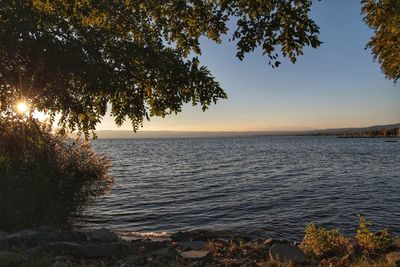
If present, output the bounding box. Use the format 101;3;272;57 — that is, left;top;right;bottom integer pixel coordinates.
0;217;400;267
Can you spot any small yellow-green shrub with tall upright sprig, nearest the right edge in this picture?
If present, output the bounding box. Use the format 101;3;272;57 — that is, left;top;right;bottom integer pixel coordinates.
355;216;393;256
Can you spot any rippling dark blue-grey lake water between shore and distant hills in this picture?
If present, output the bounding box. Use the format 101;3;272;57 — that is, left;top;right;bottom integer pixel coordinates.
77;136;400;240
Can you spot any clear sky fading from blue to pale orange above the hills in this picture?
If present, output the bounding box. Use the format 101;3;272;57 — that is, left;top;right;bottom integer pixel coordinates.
98;0;400;131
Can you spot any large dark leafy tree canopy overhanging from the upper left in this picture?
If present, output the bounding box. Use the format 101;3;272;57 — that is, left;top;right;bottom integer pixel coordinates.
0;0;320;136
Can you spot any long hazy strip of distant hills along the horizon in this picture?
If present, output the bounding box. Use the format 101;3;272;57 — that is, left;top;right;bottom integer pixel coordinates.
90;123;400;139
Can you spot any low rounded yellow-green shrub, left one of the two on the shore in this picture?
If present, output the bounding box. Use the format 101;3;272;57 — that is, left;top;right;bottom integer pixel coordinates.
300;224;350;259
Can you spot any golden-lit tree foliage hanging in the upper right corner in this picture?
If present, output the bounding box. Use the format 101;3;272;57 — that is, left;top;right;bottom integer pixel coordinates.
362;0;400;81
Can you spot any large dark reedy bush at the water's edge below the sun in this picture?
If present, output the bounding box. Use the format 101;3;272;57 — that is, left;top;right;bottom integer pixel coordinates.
0;117;113;230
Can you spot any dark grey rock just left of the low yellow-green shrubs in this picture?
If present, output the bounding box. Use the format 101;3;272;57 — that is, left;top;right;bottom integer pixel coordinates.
269;244;305;264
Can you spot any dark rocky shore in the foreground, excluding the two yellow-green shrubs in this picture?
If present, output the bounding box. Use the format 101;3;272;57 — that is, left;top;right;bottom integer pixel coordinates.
0;227;400;267
